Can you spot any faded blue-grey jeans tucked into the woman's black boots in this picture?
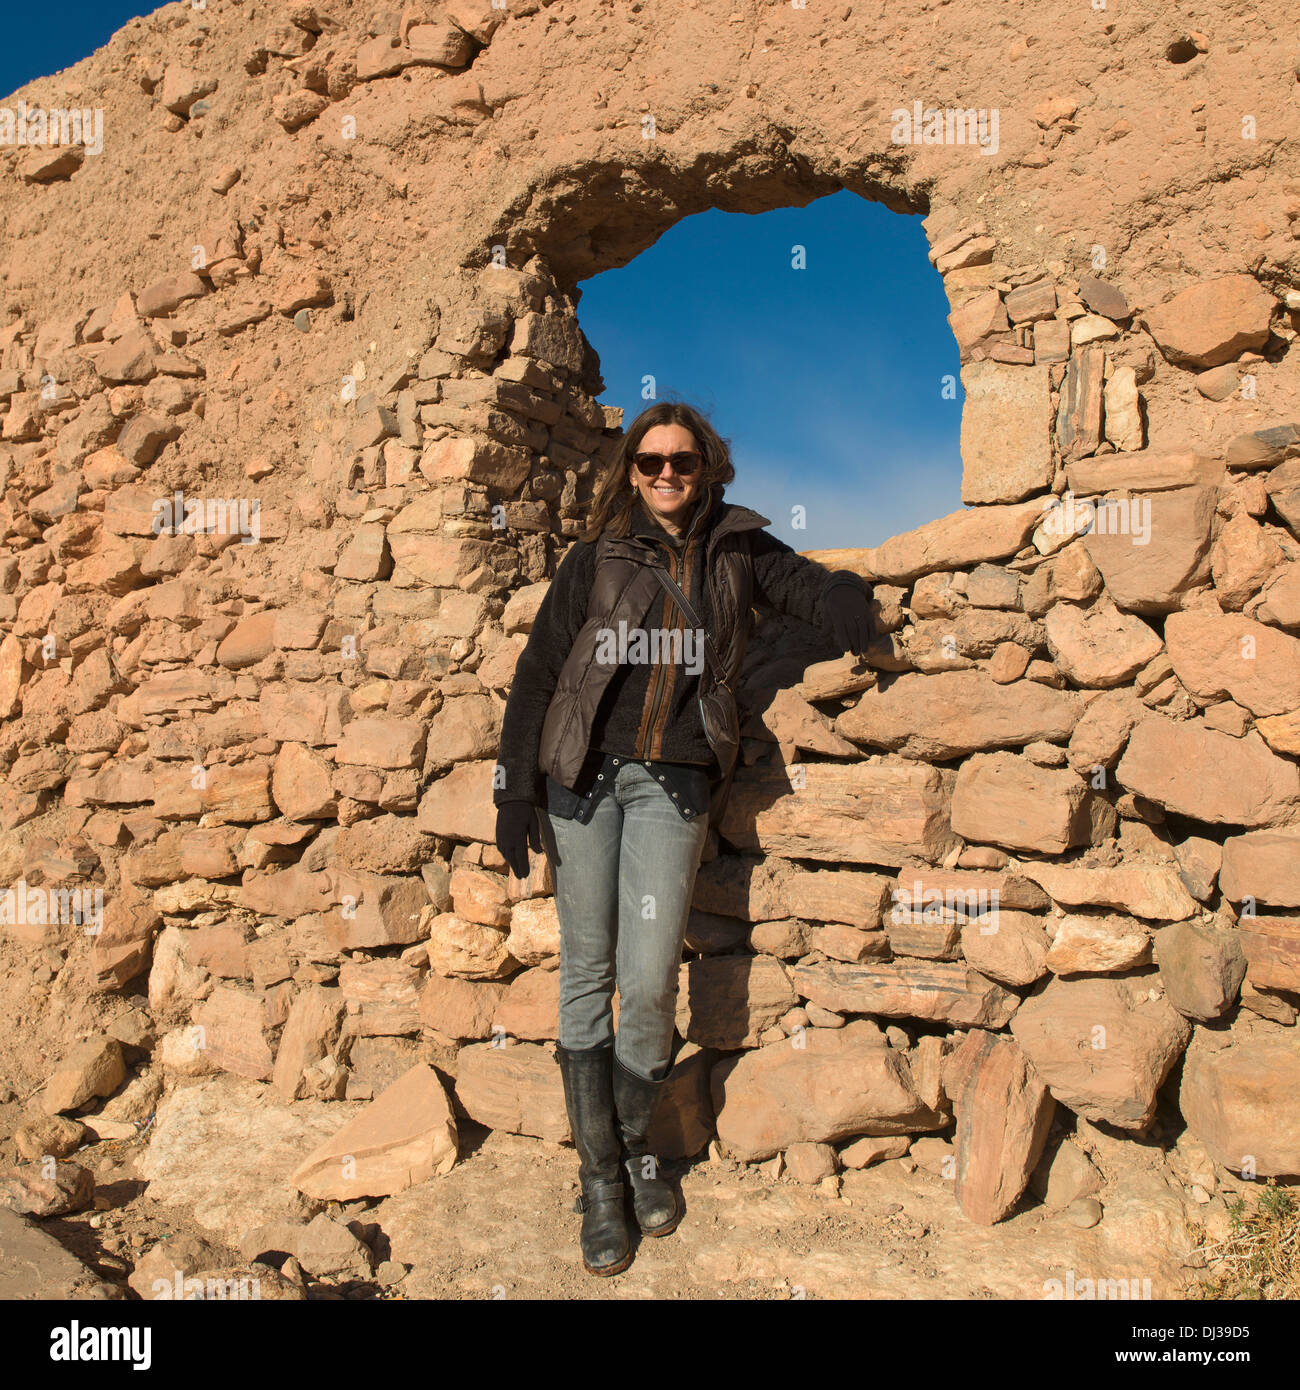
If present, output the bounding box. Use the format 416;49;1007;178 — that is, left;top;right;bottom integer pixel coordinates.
541;763;709;1081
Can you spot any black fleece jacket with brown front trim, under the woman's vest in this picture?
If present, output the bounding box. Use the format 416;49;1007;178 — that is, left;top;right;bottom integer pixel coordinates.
492;487;869;806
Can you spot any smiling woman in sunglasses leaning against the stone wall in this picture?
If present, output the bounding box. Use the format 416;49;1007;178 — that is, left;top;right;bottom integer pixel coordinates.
492;402;870;1275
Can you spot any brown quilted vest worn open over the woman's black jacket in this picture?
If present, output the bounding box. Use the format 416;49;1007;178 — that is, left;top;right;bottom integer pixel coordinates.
538;503;772;823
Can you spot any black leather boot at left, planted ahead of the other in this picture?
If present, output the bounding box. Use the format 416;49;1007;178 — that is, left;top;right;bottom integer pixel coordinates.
555;1043;633;1275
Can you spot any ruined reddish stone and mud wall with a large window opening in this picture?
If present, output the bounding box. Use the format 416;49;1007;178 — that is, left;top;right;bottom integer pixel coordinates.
0;0;1300;1295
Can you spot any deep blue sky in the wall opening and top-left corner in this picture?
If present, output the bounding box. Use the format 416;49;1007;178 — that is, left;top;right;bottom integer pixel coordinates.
10;10;961;550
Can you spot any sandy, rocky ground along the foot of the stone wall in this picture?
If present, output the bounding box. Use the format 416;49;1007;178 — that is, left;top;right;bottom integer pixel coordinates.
0;1061;1250;1300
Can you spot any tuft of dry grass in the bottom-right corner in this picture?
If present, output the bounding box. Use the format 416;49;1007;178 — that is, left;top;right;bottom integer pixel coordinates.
1187;1179;1300;1301
